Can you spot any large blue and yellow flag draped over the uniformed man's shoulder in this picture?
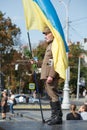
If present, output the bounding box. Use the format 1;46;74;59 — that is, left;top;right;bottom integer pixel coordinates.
22;0;68;79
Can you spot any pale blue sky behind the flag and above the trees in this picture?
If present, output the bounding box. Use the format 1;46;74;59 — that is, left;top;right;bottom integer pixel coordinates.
0;0;87;48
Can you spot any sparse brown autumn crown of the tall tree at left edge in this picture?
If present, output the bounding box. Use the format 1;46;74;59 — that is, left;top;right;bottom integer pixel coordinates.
0;11;21;52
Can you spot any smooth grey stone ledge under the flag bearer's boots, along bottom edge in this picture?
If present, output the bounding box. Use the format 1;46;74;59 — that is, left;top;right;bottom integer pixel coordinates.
0;121;87;130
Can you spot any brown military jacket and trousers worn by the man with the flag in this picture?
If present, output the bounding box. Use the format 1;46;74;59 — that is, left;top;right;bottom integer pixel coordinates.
41;43;59;102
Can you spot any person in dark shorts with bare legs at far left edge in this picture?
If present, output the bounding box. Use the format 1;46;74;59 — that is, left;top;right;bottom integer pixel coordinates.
1;91;8;119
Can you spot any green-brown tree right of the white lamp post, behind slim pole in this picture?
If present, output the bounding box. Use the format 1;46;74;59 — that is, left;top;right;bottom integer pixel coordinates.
69;44;87;93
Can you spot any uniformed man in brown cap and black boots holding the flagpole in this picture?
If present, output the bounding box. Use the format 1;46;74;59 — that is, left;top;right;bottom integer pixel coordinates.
41;27;62;125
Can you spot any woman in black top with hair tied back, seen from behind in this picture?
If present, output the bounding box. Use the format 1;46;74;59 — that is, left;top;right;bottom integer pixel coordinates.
66;104;82;120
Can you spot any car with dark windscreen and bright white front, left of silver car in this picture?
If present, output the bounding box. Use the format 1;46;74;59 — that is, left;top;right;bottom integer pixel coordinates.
15;94;28;104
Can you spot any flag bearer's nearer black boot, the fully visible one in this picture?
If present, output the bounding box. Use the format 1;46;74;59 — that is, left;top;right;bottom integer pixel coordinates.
48;101;63;125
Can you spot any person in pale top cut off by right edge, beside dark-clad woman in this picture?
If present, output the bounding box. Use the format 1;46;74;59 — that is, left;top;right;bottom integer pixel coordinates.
79;104;87;120
